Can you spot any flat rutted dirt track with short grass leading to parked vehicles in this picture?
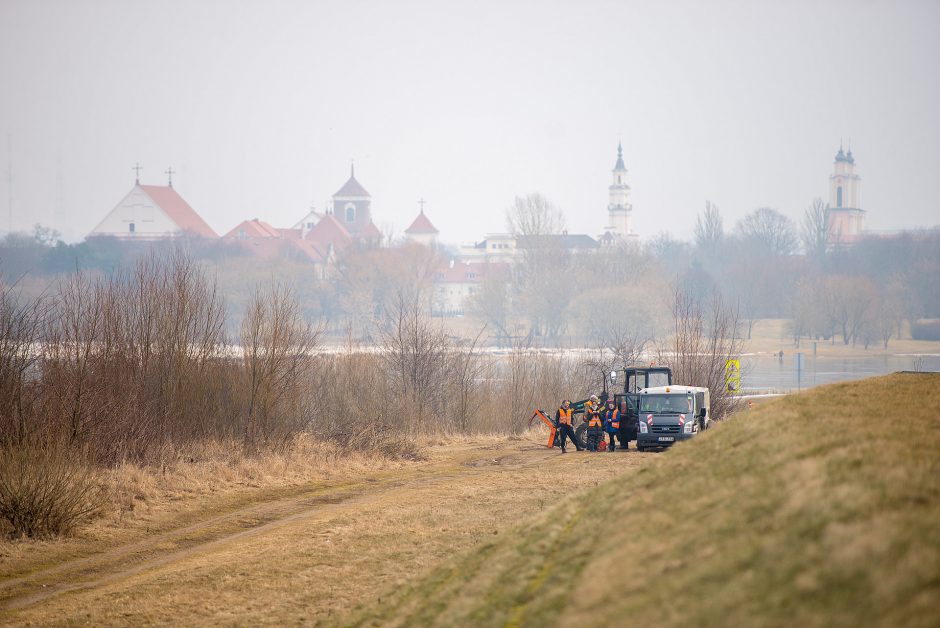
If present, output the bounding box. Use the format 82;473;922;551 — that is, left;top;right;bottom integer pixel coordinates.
0;440;651;624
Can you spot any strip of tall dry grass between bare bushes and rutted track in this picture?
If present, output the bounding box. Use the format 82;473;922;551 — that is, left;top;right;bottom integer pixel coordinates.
0;434;420;577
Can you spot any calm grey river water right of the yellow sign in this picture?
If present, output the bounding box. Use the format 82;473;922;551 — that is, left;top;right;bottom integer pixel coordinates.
741;349;940;392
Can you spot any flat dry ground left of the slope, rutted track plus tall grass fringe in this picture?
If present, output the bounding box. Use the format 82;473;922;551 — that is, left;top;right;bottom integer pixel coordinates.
0;434;656;625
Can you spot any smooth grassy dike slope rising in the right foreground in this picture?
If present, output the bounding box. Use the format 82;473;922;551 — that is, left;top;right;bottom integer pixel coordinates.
357;373;940;626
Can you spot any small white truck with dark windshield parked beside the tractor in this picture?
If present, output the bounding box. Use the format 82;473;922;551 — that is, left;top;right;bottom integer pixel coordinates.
636;386;711;451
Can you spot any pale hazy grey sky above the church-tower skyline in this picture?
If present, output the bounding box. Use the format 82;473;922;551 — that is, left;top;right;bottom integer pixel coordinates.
0;0;940;242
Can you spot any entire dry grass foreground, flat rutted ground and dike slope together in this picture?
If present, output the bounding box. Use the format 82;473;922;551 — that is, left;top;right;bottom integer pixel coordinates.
0;374;940;626
